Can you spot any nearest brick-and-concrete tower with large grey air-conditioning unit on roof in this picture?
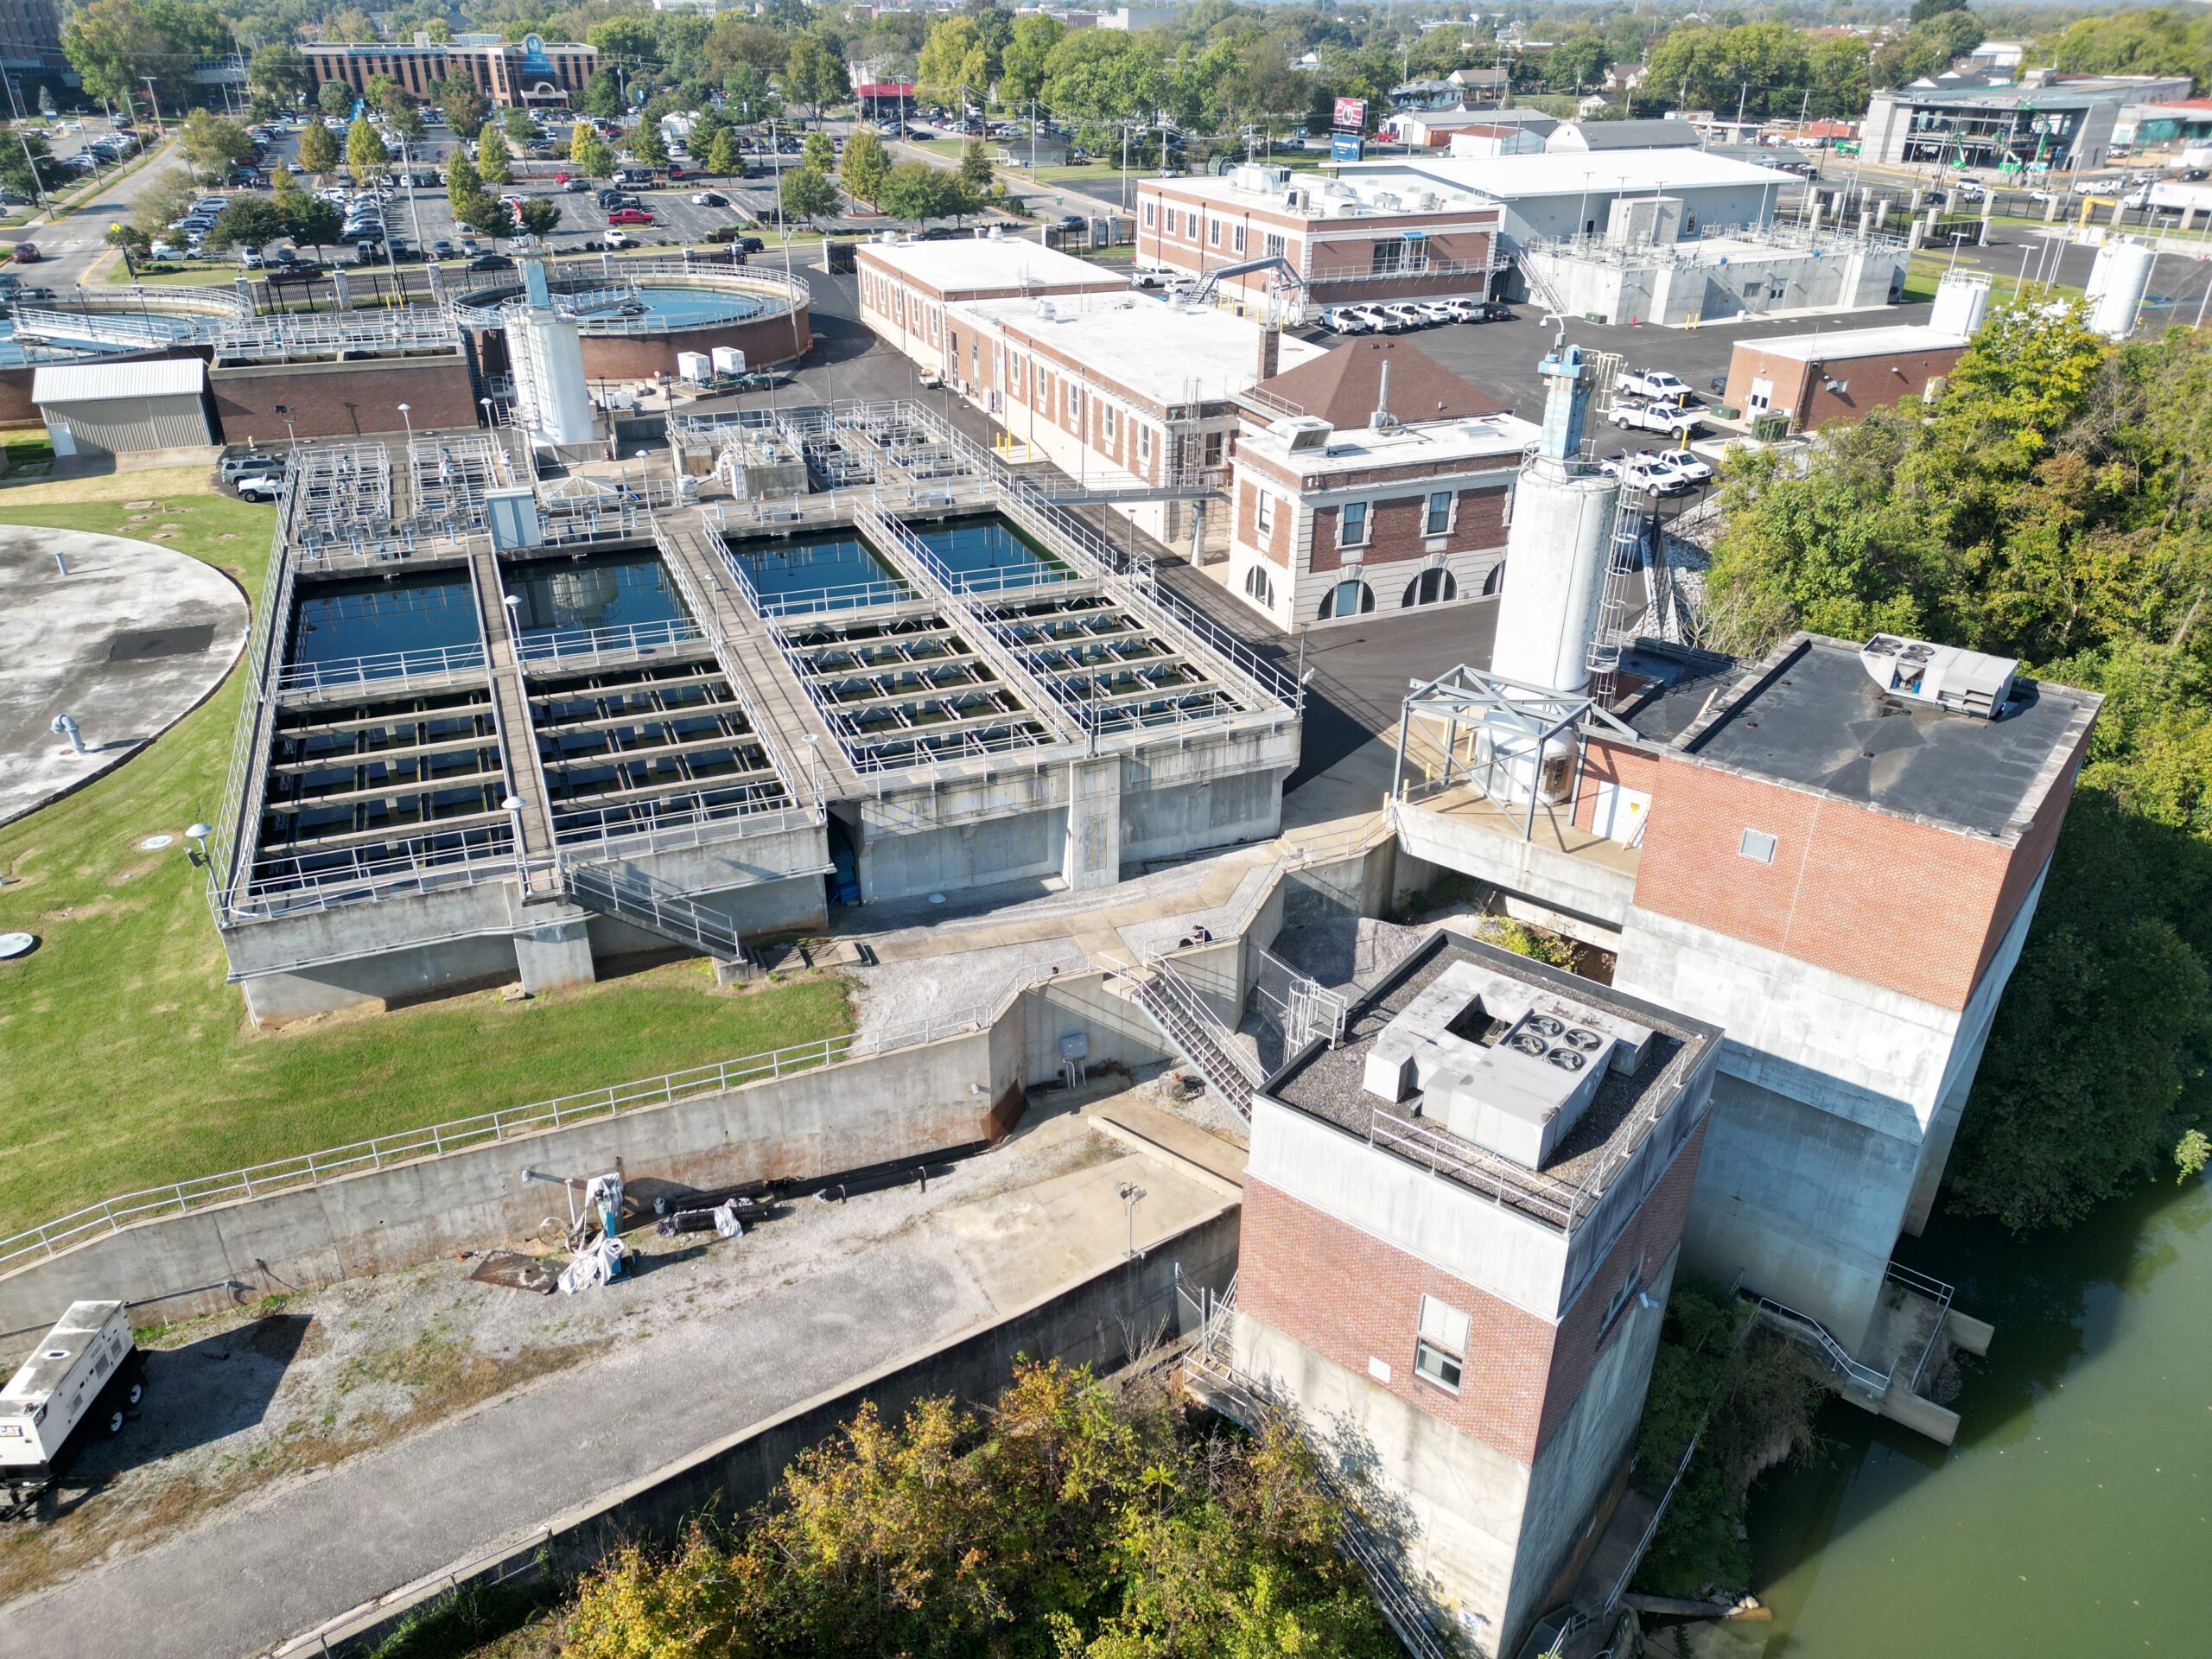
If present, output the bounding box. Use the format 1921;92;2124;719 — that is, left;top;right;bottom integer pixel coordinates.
1232;933;1721;1652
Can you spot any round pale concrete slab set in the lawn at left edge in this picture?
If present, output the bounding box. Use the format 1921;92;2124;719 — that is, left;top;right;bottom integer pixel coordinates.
0;520;248;834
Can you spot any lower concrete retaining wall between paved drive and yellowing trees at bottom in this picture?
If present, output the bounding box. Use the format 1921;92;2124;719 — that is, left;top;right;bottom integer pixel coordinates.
276;1208;1239;1659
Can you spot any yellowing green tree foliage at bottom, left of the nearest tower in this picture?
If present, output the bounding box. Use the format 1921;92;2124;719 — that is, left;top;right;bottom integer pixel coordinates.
562;1363;1395;1659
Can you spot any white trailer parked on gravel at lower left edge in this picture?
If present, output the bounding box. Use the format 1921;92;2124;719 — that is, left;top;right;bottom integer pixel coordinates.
0;1303;146;1520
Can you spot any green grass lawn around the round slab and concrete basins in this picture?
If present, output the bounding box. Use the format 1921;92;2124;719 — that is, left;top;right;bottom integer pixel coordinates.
0;486;852;1232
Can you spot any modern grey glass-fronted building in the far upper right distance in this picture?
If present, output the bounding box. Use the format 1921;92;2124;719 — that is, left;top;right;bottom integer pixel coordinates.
1860;71;2192;173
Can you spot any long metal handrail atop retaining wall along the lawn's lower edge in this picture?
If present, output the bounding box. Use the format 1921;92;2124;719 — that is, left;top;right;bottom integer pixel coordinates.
0;1007;987;1272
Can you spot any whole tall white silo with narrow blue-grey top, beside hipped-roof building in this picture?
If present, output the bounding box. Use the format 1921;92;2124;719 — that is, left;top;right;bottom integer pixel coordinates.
1491;345;1621;695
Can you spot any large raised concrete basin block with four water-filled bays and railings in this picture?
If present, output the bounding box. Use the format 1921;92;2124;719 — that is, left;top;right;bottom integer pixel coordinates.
193;402;1300;1022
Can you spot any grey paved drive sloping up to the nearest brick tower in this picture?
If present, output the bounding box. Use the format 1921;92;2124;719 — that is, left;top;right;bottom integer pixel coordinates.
0;1102;1236;1659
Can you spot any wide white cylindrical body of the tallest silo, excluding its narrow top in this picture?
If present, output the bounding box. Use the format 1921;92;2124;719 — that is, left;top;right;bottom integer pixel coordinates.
1491;460;1621;692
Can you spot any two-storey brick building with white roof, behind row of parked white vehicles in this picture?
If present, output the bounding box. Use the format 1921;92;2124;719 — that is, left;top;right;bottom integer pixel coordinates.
1137;163;1502;321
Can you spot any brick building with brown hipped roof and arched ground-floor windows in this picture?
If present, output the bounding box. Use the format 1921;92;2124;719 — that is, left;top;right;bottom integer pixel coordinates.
1230;339;1537;631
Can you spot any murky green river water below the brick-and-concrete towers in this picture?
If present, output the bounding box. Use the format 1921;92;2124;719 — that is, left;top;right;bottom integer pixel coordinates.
1726;1179;2212;1659
